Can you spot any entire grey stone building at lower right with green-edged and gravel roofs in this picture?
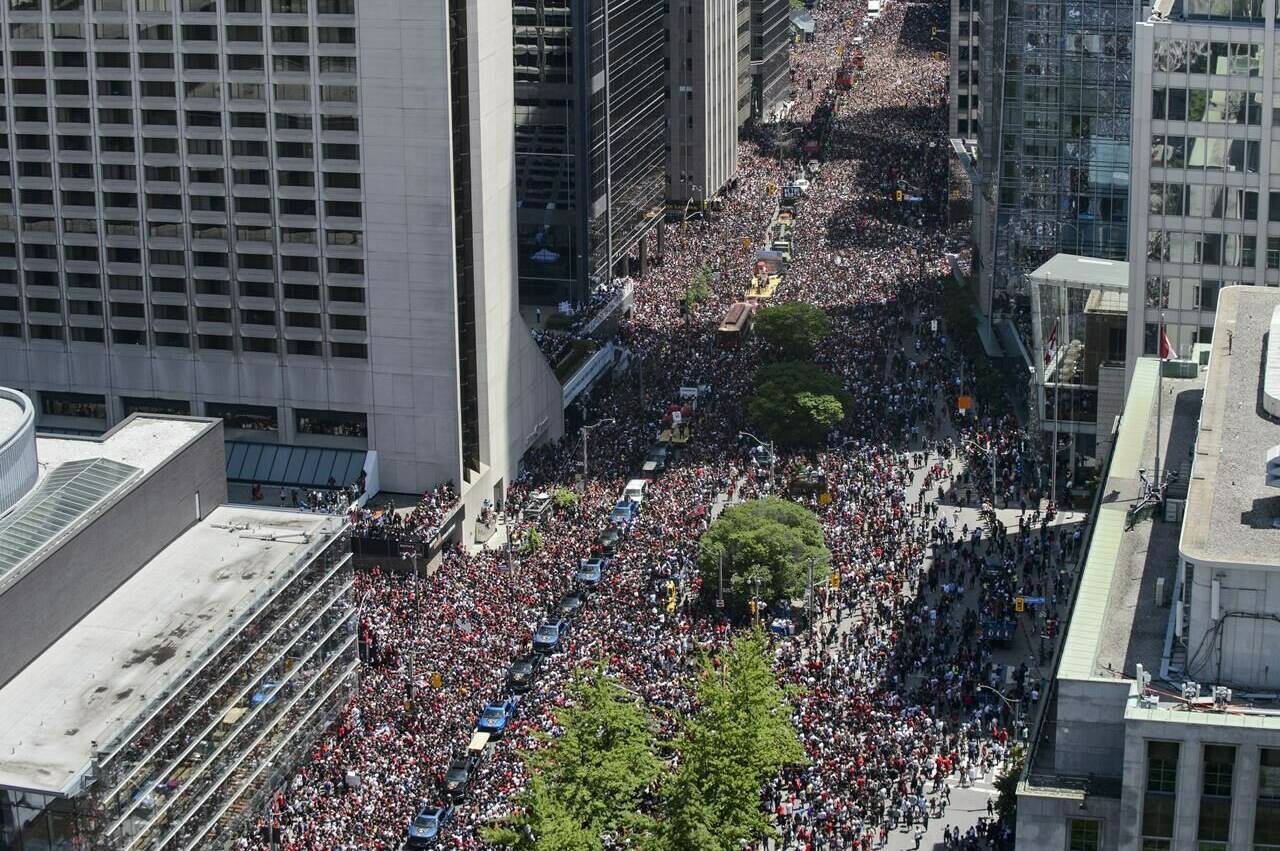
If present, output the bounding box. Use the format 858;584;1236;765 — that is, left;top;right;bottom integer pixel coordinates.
1018;287;1280;851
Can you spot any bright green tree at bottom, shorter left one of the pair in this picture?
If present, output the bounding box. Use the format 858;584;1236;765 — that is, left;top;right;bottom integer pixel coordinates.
484;667;662;851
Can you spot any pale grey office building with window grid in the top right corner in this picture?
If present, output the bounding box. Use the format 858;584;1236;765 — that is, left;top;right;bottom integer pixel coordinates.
1126;8;1280;372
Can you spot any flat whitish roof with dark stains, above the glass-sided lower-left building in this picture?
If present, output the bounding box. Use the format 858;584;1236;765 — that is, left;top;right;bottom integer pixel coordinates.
0;505;343;792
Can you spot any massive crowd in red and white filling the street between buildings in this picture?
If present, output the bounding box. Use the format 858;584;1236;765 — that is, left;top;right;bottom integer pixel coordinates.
232;0;1049;851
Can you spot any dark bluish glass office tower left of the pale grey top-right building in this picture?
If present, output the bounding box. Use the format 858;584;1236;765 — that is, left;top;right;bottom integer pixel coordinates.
974;0;1138;315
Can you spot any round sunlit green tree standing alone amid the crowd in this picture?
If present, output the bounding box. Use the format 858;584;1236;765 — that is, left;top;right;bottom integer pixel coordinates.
699;497;831;601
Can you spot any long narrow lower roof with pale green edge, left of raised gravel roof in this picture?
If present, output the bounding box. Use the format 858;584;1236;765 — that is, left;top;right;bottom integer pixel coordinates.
1059;358;1204;680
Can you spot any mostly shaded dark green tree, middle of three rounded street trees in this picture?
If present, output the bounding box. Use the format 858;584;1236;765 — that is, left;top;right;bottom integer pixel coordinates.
746;361;854;445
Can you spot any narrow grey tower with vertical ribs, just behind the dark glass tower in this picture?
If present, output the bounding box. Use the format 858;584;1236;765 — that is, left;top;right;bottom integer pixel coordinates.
667;0;741;205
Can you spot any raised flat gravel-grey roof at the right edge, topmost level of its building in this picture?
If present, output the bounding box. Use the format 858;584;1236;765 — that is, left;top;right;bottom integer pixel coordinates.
1181;287;1280;567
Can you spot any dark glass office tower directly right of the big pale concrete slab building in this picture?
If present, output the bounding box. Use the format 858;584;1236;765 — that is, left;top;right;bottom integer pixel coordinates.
512;0;667;303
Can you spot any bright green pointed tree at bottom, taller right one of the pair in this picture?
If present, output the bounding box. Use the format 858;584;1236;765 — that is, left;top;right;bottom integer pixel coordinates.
657;630;805;851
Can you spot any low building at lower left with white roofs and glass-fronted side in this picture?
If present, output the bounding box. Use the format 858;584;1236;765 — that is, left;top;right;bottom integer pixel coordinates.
0;415;358;851
